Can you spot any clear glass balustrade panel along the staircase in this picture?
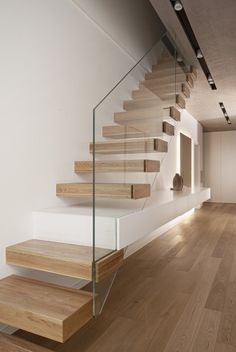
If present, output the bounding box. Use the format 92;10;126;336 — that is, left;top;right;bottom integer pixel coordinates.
91;33;189;316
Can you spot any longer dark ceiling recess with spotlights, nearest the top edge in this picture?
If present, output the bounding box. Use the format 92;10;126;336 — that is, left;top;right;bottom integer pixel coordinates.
170;0;217;90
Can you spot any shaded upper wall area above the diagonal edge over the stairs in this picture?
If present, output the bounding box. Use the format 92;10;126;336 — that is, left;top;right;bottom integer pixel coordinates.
73;0;165;61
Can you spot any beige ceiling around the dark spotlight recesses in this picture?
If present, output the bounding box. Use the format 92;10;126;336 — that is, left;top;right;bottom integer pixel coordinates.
150;0;236;131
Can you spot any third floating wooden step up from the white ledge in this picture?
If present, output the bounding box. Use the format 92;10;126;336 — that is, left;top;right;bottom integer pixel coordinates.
90;138;168;154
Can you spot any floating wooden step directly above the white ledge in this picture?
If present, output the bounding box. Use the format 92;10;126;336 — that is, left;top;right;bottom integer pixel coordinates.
57;183;150;199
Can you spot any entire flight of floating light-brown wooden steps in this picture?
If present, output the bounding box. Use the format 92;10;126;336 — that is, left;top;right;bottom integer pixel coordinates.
0;48;197;352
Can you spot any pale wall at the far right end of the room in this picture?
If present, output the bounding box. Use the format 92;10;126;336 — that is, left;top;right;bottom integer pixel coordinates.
204;131;236;203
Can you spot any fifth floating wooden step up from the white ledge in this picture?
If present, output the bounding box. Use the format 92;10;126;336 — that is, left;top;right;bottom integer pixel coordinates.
114;106;180;124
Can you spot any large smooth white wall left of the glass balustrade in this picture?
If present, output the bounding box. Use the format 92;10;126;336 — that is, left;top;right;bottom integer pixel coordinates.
0;0;165;277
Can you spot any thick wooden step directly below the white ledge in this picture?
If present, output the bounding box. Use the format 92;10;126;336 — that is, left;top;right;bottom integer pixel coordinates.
6;240;124;282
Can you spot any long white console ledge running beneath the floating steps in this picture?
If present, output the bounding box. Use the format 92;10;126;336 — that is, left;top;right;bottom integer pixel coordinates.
33;188;210;249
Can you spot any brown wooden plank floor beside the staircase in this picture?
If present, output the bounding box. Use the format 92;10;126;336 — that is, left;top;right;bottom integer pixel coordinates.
15;204;236;352
